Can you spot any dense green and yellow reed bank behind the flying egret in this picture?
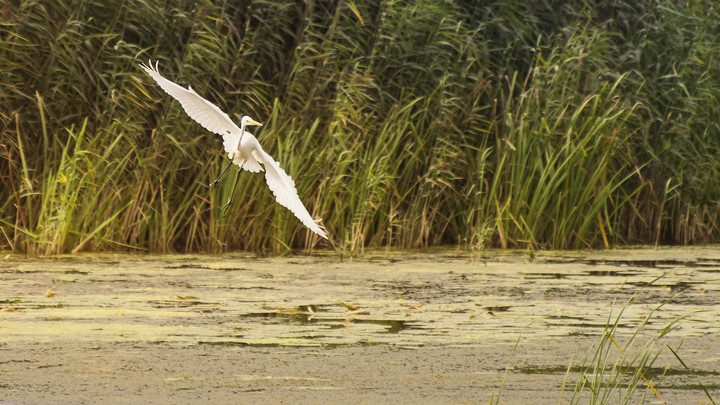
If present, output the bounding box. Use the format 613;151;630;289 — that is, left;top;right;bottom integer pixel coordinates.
0;0;720;253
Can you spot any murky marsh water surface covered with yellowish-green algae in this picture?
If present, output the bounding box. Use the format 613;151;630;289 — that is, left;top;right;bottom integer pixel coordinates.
0;247;720;404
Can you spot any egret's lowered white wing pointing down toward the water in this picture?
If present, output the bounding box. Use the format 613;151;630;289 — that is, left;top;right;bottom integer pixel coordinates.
253;147;328;239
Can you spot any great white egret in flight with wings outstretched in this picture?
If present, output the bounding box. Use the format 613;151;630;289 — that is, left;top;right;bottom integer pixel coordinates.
140;61;327;239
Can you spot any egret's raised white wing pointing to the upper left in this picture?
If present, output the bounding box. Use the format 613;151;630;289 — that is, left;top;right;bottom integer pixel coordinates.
140;61;240;142
